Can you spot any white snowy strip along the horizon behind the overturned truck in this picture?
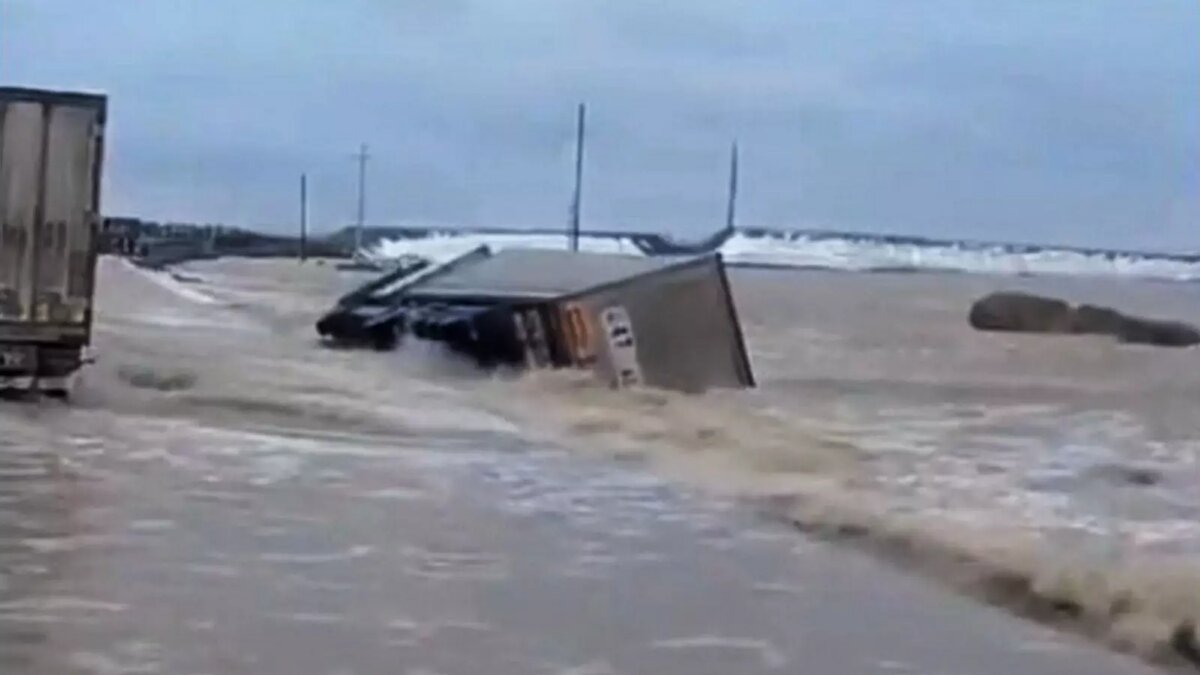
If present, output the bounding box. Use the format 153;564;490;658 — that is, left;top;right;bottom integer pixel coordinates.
368;229;1200;281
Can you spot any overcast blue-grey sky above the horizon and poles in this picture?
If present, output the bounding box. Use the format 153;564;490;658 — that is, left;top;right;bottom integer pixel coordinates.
0;0;1200;249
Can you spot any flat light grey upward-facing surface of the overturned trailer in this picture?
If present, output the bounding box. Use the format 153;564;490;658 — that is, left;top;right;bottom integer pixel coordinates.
407;249;679;300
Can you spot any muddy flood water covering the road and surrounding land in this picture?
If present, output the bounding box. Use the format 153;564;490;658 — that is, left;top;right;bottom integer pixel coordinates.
0;261;1180;675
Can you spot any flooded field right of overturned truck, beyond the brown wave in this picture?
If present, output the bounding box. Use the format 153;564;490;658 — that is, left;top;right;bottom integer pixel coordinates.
740;267;1200;562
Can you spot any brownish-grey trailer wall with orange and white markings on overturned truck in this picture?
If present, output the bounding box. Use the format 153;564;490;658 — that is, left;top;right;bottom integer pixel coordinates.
559;256;755;392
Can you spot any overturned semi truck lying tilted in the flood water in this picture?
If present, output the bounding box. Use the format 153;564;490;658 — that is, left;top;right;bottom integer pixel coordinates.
317;246;755;392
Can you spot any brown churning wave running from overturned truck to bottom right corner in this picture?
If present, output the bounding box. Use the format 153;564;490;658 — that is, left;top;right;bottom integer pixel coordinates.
474;371;1200;665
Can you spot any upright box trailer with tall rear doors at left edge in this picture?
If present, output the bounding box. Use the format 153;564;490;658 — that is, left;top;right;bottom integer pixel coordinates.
0;88;108;396
